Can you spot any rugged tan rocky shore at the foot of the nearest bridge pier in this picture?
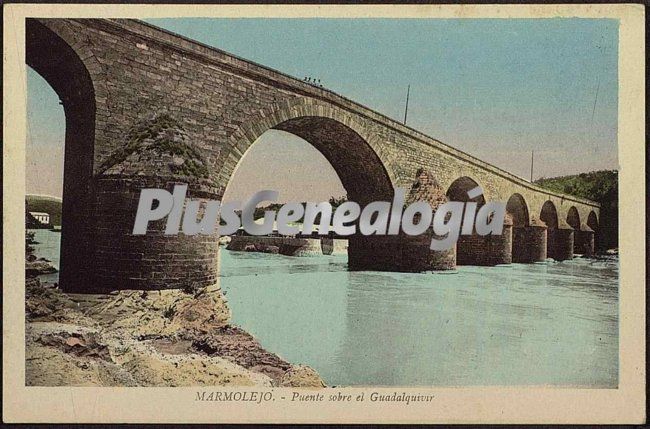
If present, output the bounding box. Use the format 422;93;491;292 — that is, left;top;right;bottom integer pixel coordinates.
25;275;325;388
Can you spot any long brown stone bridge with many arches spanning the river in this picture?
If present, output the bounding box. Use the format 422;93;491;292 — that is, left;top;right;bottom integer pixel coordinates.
26;19;599;292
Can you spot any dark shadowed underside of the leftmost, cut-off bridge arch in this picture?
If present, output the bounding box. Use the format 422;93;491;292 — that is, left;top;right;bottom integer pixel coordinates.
25;19;96;289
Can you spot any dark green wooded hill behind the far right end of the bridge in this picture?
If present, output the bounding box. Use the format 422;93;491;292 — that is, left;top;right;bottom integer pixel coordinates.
535;170;618;249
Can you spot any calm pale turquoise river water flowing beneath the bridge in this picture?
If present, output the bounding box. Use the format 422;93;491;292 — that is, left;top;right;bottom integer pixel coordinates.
30;230;618;388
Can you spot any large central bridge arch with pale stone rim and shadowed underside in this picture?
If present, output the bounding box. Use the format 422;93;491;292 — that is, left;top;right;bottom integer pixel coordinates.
223;101;405;270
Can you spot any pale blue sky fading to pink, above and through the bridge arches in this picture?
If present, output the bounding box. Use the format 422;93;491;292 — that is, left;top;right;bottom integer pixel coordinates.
28;18;618;200
